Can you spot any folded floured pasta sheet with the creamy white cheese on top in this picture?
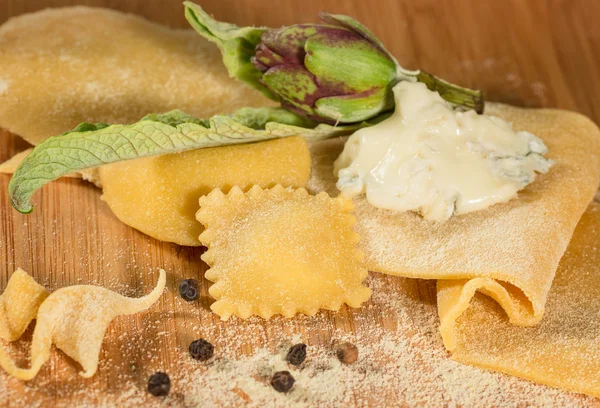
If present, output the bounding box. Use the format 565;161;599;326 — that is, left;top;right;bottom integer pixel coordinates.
309;104;600;334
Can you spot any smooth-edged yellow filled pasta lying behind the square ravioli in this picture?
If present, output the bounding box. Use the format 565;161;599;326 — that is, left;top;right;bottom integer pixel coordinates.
100;137;310;246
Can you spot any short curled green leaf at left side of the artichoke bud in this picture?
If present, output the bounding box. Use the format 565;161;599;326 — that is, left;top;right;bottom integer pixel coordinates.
183;1;278;100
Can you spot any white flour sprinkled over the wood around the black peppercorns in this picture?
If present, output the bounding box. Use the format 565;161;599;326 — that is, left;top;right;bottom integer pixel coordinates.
0;274;595;407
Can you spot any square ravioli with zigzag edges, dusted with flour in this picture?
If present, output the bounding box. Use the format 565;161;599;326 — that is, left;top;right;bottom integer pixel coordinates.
196;186;371;320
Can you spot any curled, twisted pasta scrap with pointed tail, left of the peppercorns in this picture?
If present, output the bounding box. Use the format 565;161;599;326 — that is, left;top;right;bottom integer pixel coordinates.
0;270;166;380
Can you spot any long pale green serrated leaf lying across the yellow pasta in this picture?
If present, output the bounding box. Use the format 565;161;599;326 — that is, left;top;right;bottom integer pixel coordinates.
8;108;369;213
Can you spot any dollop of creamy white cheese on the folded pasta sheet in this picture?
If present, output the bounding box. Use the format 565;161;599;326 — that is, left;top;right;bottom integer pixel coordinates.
335;81;552;222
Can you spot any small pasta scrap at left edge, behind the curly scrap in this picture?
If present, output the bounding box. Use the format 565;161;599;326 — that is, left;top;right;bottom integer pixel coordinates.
0;268;50;341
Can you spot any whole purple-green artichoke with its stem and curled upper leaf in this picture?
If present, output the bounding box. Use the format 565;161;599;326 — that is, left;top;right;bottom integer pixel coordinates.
184;2;483;123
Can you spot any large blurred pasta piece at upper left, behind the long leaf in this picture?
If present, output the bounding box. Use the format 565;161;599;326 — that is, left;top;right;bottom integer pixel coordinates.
0;7;269;145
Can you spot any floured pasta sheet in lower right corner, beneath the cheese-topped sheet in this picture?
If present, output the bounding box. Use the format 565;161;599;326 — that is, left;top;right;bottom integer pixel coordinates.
438;203;600;396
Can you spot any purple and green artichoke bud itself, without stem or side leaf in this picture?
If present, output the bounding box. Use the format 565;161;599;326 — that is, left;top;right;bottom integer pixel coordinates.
252;24;397;123
